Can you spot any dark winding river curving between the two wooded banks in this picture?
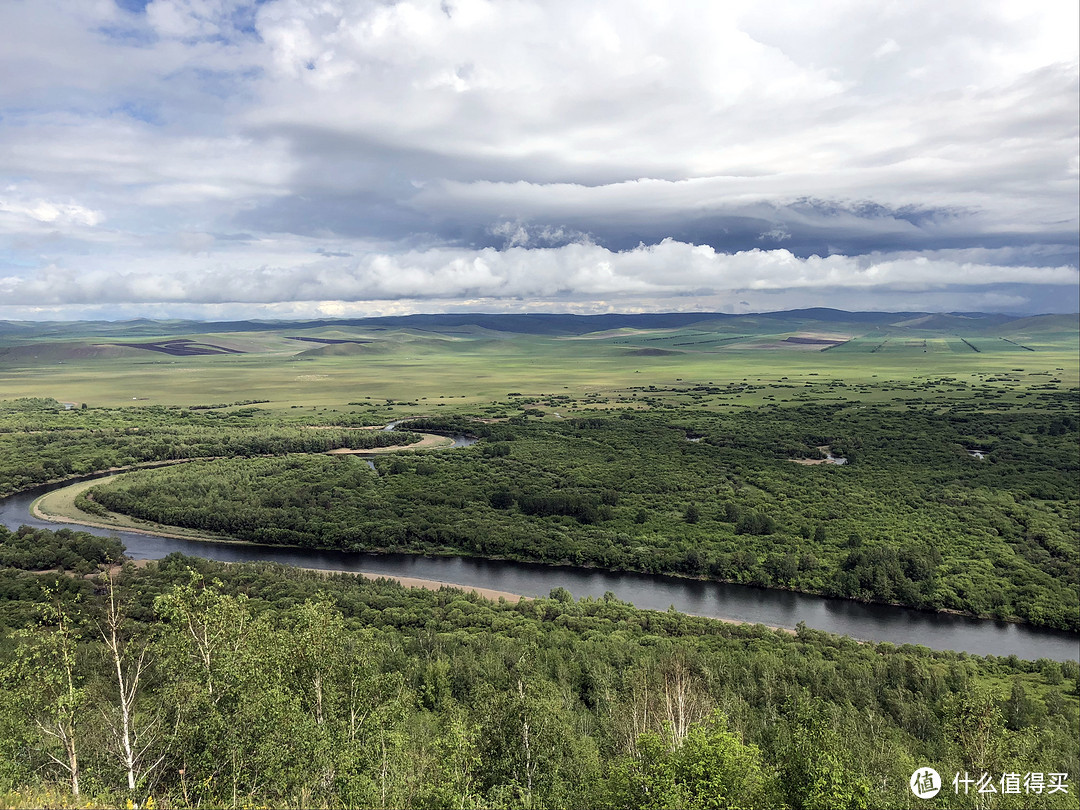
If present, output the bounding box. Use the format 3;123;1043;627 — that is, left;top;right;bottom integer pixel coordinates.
0;466;1080;661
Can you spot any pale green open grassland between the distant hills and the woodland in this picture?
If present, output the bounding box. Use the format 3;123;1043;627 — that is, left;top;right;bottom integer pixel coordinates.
0;315;1080;414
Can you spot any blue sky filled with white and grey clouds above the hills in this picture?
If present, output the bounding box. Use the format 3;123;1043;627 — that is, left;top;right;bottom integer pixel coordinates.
0;0;1080;321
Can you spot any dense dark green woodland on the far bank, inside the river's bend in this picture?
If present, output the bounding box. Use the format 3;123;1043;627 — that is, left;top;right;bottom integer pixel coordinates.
91;403;1080;630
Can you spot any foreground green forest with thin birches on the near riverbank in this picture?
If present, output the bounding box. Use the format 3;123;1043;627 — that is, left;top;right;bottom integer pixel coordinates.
0;527;1080;810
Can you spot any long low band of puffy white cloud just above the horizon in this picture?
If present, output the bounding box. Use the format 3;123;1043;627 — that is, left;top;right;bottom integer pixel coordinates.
0;240;1078;306
